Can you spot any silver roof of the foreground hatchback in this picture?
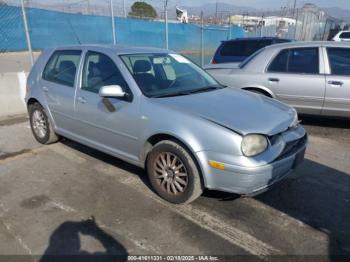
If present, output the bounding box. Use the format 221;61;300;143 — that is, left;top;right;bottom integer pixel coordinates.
50;44;171;54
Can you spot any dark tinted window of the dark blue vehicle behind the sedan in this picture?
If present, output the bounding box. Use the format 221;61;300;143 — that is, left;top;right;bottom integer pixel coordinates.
220;40;272;56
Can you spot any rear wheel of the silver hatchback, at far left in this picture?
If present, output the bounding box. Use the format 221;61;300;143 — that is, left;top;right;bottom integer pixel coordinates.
28;103;59;145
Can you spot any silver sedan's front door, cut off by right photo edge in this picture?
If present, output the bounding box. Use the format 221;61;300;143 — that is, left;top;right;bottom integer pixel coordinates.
322;47;350;117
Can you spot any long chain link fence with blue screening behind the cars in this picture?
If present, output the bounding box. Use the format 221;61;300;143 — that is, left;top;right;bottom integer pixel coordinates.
0;0;344;71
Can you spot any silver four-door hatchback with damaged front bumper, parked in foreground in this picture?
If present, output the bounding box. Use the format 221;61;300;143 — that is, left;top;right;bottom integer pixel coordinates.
26;45;307;203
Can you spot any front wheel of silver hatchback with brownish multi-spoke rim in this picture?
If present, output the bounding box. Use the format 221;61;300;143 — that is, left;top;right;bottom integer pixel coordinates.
147;140;203;204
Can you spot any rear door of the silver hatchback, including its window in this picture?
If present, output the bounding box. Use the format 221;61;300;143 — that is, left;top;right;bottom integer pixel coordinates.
41;50;82;130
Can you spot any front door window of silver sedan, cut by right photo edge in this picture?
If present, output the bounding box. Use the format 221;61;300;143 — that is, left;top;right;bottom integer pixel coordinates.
327;48;350;76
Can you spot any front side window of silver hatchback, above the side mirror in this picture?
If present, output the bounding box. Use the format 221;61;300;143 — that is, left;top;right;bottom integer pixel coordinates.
81;51;128;93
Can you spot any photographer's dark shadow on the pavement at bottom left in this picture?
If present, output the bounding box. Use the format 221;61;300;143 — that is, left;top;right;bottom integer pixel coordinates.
40;218;128;262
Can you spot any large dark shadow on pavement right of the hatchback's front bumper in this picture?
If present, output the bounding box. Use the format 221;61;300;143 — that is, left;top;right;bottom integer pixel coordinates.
262;159;350;260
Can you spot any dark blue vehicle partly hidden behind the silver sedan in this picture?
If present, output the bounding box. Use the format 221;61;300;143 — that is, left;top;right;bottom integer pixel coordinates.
208;37;291;67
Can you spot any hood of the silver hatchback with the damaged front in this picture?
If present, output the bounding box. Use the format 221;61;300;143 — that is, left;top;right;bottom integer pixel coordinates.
154;88;296;136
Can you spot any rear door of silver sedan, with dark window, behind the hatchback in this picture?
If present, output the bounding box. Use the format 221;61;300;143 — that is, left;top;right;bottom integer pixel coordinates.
263;47;325;114
